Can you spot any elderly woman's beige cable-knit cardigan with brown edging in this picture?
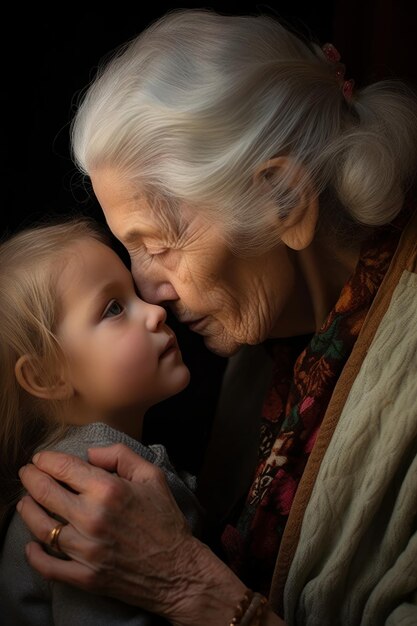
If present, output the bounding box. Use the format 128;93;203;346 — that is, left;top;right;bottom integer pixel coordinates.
200;208;417;626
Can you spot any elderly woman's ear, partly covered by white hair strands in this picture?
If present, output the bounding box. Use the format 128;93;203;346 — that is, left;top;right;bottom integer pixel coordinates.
254;156;319;250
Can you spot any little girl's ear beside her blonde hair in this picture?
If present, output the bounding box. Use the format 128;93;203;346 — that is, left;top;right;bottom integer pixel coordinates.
14;354;73;400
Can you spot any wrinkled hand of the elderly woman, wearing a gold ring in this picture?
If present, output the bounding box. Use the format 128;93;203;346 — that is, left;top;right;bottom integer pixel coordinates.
18;444;245;626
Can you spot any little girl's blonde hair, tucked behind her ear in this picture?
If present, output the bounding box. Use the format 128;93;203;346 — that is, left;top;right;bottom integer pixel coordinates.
0;217;109;525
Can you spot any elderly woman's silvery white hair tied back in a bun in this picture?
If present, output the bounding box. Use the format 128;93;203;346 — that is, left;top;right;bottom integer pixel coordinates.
72;9;417;251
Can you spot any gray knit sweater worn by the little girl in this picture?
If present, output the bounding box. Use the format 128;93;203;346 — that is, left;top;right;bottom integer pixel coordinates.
0;423;201;626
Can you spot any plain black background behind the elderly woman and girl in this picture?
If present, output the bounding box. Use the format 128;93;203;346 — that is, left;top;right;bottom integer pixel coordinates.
1;0;417;471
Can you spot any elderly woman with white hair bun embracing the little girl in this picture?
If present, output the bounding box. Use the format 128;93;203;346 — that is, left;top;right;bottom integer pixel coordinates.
14;10;417;626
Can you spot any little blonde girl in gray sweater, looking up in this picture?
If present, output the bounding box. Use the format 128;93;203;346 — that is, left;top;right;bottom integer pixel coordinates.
0;218;200;626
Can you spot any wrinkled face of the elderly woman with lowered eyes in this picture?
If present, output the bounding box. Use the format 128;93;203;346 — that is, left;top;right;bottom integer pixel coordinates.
92;170;309;356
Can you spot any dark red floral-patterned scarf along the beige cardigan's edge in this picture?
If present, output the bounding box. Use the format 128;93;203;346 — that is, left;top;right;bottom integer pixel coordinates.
222;226;401;595
